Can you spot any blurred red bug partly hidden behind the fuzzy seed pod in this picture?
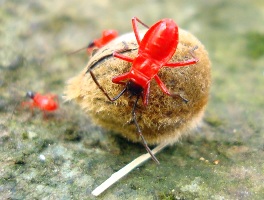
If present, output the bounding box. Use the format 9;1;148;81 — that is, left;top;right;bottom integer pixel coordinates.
86;30;118;54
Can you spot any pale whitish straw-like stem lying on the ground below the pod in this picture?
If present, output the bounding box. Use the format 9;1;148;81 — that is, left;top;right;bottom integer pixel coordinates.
92;142;169;196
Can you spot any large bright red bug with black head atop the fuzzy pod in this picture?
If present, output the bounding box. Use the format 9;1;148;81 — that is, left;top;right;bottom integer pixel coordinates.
88;17;198;163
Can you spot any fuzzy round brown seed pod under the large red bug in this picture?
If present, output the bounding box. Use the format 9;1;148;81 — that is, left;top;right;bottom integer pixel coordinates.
65;29;211;144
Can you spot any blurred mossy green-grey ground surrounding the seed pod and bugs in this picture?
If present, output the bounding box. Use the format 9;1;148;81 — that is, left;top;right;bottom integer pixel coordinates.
0;0;264;199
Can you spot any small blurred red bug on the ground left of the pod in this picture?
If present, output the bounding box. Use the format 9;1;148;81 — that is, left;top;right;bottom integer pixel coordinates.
22;91;59;117
